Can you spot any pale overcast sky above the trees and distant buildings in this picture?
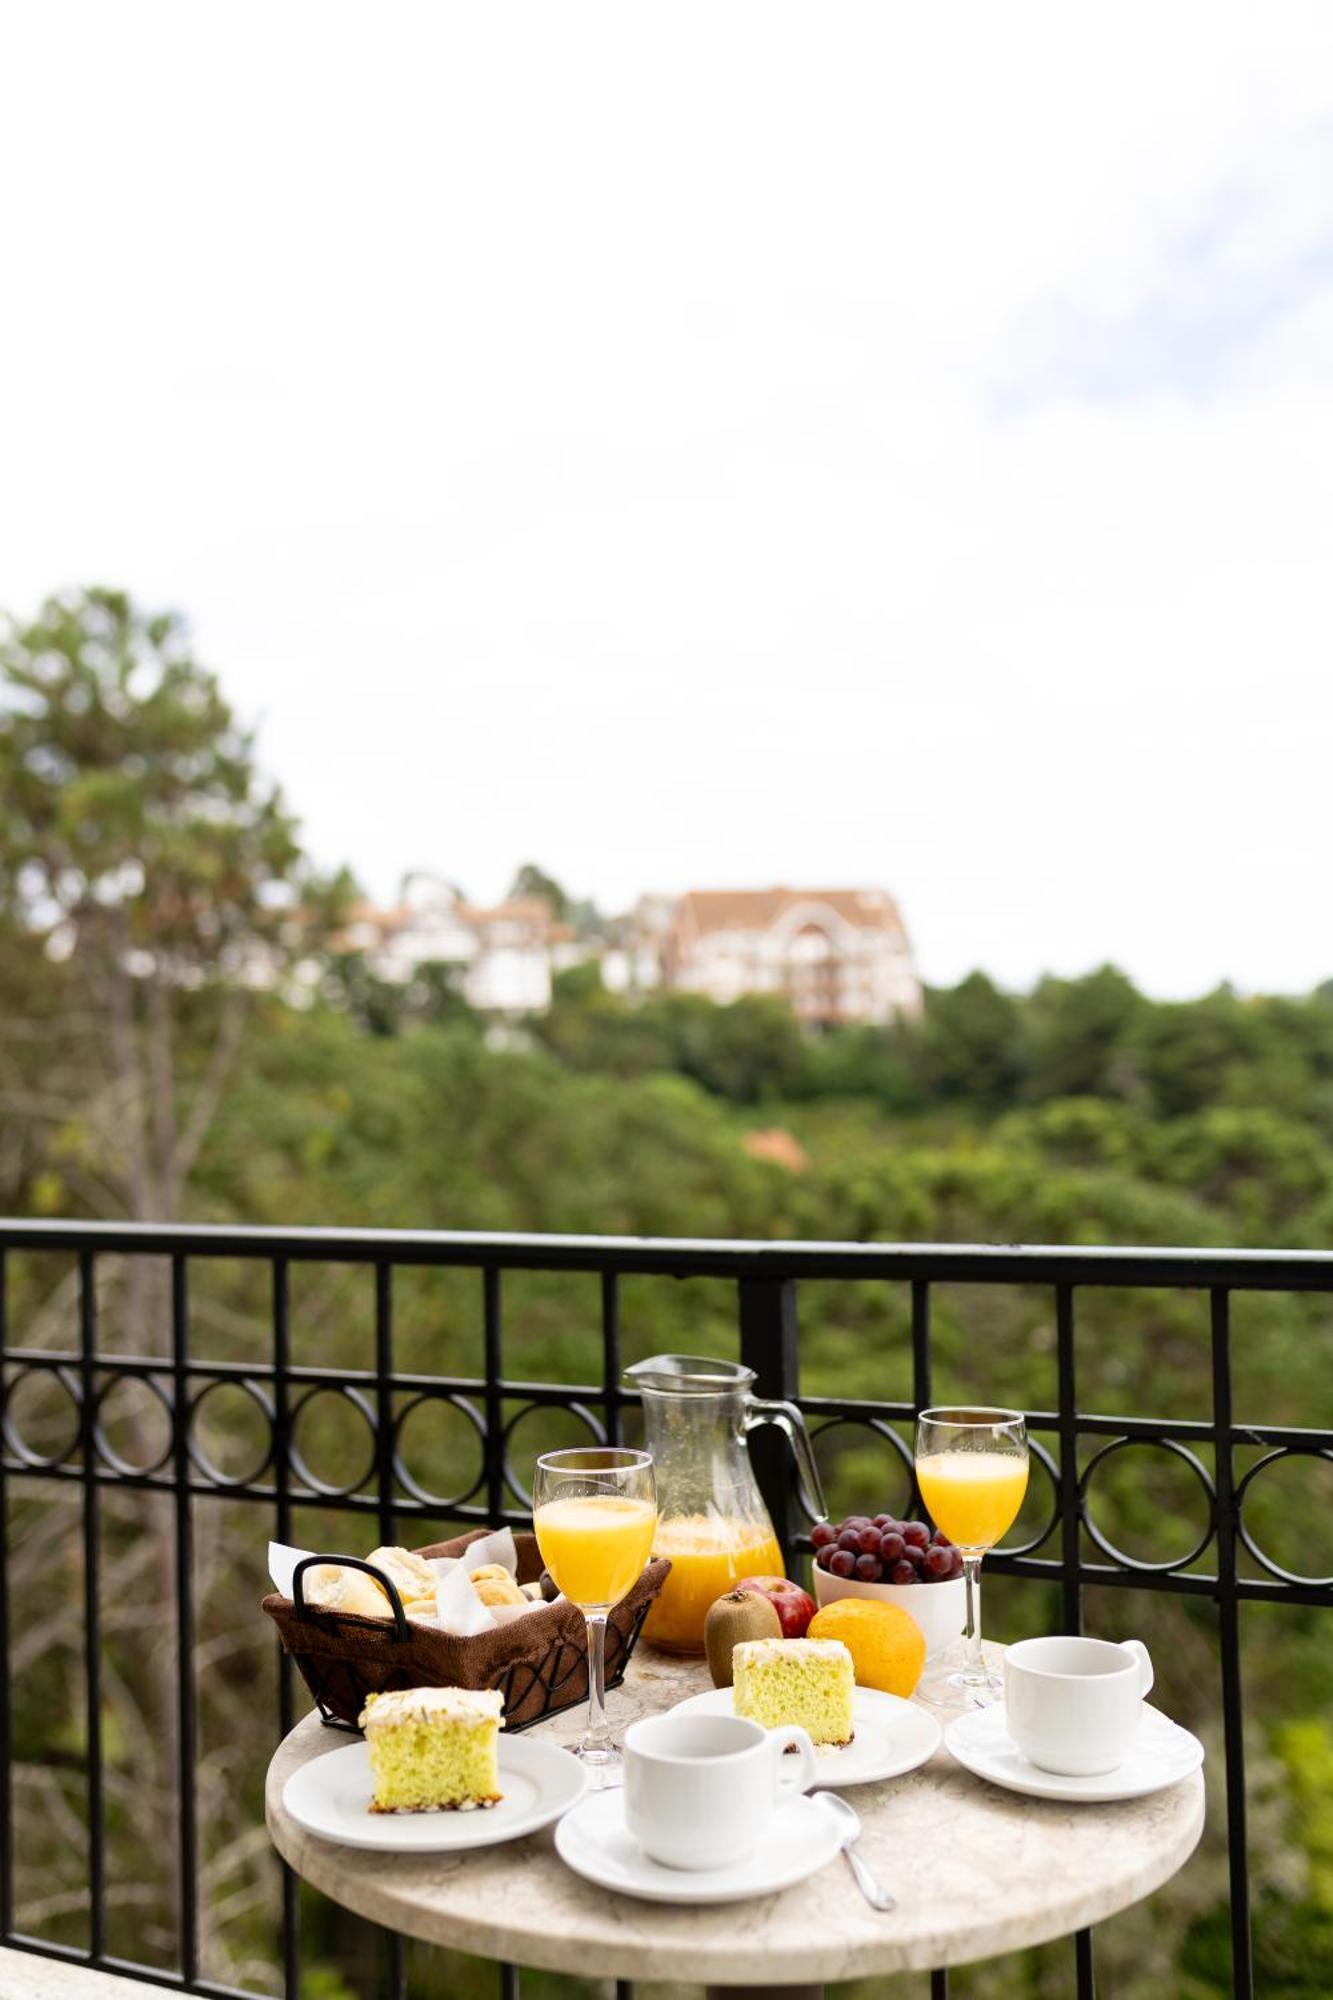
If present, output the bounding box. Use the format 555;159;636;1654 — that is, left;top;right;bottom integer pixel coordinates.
0;0;1333;994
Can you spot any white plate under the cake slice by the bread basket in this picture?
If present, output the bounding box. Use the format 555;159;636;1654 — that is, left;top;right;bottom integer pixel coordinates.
282;1736;586;1854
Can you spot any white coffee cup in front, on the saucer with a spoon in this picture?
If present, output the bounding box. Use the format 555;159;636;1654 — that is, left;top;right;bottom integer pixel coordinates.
624;1716;819;1868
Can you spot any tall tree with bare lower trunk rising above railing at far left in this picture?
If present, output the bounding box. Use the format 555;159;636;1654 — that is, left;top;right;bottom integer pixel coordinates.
0;590;346;1220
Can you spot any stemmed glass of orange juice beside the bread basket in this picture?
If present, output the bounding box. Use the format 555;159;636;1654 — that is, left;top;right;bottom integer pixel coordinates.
532;1444;656;1786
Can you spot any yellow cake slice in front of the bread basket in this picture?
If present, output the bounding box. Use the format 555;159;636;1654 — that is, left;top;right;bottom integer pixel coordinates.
360;1688;504;1812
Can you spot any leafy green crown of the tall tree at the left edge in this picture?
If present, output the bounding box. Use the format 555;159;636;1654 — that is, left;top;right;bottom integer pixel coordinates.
0;590;342;980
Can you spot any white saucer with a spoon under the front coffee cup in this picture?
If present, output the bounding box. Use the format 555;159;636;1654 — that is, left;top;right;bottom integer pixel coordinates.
556;1792;843;1908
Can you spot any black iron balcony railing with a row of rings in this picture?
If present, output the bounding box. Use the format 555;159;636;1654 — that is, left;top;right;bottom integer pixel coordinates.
0;1222;1333;2000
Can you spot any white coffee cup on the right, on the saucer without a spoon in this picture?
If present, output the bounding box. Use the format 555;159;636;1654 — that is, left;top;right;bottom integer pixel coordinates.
1005;1638;1153;1778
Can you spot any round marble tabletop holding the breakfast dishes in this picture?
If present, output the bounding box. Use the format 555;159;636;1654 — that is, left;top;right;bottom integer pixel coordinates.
266;1646;1203;1990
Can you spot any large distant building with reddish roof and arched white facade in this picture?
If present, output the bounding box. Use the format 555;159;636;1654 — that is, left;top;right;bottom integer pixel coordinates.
662;888;921;1026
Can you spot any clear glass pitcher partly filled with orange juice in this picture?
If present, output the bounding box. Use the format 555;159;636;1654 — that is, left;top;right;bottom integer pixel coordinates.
624;1354;825;1652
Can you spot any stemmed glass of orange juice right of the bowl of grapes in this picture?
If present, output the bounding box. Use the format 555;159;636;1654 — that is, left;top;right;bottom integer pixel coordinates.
917;1408;1027;1706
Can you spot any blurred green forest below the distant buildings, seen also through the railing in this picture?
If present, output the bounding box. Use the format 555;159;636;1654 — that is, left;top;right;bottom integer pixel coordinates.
0;592;1333;2000
